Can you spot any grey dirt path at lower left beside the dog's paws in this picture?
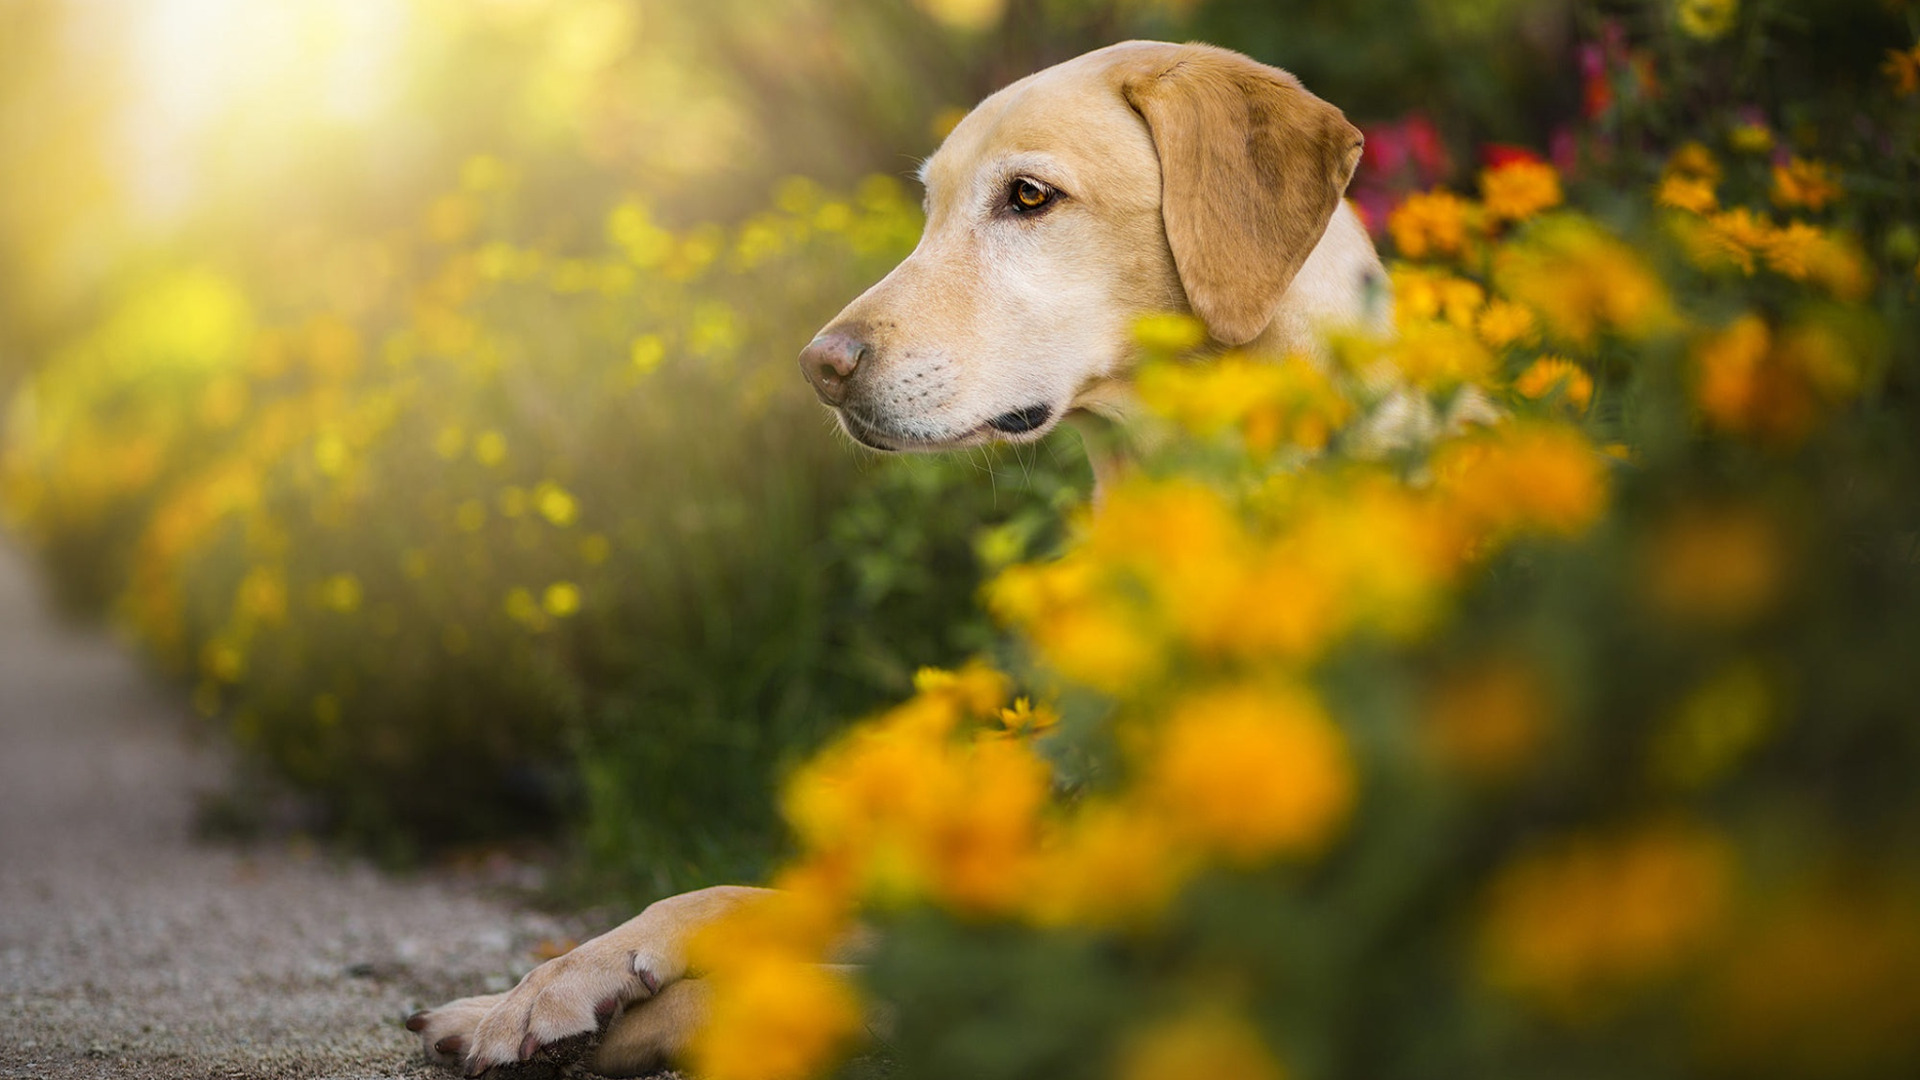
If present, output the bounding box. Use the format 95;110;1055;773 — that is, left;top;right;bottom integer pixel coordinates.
0;542;578;1080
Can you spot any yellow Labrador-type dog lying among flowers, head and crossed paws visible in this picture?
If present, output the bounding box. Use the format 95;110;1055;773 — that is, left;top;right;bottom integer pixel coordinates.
407;42;1384;1076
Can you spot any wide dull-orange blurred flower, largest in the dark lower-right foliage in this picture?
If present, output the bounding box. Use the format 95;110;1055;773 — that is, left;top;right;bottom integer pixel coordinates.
1480;822;1734;1017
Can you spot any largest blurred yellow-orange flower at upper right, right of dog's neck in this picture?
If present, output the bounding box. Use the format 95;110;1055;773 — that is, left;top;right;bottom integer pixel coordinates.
1494;215;1676;346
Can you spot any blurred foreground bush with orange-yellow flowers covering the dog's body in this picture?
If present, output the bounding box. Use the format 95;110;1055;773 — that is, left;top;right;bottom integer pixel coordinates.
693;4;1920;1080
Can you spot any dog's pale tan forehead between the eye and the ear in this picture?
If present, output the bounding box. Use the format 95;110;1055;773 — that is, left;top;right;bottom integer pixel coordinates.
920;54;1150;194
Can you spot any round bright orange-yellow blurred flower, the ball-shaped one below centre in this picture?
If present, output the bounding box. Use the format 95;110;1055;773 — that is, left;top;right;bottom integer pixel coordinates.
1142;686;1356;865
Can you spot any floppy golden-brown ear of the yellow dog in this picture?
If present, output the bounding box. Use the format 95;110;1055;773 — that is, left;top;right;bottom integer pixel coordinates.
1116;44;1361;346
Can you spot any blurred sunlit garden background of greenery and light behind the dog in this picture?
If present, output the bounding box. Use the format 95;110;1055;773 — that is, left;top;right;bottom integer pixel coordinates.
0;0;1905;897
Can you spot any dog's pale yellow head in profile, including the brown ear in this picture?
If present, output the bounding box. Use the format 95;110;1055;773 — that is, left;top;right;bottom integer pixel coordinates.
801;42;1361;450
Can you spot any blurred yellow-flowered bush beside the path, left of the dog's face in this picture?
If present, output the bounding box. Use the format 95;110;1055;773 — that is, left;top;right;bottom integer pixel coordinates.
4;170;1066;864
